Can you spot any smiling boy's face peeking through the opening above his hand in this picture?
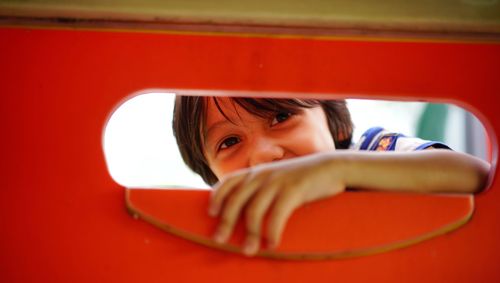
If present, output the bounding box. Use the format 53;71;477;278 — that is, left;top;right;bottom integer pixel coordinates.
203;98;335;180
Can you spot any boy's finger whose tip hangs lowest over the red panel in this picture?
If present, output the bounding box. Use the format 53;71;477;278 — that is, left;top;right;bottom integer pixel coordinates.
243;184;279;255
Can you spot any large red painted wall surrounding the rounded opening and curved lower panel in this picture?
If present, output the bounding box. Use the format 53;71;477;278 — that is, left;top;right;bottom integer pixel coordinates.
0;28;500;282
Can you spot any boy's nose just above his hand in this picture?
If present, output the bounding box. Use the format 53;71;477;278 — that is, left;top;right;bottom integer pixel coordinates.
249;138;285;167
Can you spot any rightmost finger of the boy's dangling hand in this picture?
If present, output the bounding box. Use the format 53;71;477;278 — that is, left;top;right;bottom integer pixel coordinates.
266;192;299;249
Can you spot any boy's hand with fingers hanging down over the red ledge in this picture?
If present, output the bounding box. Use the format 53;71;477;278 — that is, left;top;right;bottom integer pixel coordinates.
209;155;345;255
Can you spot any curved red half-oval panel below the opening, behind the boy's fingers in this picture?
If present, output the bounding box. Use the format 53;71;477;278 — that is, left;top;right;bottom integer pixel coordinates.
126;189;474;259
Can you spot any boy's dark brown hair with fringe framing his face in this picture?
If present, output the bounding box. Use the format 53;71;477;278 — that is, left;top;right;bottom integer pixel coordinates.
172;96;353;185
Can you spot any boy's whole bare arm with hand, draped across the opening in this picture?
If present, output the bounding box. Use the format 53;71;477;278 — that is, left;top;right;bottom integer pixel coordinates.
209;149;490;255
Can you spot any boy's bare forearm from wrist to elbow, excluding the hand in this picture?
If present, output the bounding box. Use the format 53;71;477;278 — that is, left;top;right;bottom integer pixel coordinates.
329;149;490;193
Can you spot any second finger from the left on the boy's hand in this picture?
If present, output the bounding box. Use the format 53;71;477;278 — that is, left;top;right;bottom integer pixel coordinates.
214;175;261;243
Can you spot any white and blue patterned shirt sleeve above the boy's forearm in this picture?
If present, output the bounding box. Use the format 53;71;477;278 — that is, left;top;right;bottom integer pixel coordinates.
353;127;450;151
